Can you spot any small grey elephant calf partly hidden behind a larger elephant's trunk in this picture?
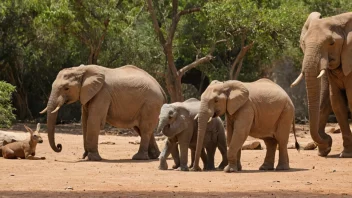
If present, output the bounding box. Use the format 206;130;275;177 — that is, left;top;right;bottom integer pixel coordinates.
157;98;227;171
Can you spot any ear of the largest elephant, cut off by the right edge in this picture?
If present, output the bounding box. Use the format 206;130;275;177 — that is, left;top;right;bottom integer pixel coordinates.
341;19;352;76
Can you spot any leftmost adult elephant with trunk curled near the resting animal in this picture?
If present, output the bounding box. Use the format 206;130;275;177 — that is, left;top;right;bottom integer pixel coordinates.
41;65;166;161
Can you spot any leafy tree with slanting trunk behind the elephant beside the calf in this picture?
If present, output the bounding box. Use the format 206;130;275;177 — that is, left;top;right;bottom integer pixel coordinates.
204;0;306;81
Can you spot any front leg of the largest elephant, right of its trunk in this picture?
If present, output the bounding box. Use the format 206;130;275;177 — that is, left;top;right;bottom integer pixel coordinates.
330;83;352;157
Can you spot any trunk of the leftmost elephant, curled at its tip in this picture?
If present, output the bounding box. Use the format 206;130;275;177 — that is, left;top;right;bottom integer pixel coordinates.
47;89;64;152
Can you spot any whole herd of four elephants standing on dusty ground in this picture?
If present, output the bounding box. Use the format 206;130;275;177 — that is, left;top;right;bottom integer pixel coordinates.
41;12;352;172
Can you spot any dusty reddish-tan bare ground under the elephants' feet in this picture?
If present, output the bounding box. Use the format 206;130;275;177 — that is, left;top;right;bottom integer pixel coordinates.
0;124;352;197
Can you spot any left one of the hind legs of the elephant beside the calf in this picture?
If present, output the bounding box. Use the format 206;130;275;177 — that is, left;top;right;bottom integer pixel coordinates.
259;138;277;170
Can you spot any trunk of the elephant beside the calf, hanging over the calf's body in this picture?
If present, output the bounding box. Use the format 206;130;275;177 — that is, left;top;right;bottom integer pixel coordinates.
193;100;214;170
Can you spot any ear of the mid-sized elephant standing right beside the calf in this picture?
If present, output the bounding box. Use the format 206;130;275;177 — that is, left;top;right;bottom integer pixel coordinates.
226;80;249;115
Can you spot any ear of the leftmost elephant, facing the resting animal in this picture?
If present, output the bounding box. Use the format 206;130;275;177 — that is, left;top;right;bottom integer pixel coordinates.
80;66;105;105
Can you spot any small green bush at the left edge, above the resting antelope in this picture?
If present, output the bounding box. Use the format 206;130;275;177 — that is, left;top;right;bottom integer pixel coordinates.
0;81;16;128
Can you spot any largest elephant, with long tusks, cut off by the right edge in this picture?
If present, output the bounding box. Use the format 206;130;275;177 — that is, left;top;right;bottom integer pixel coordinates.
293;12;352;157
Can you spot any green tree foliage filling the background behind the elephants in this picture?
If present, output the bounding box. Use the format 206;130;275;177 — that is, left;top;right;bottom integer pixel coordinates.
0;0;352;119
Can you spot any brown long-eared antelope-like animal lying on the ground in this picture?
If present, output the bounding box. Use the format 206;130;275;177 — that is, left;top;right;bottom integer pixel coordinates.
2;123;45;160
